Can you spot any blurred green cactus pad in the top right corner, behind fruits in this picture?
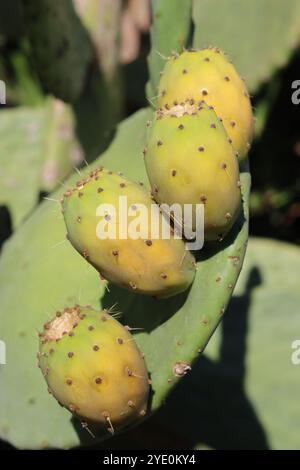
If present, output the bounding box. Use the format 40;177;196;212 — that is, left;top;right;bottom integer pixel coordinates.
193;0;300;93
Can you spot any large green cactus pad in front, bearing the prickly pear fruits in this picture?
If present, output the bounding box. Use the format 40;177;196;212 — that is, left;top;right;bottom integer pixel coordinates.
0;110;250;449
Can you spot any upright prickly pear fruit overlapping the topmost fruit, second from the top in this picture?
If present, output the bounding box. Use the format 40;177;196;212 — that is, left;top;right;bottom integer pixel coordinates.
145;103;241;240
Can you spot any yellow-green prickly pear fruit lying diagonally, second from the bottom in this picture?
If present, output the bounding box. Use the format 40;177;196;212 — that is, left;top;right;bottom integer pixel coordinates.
62;168;195;297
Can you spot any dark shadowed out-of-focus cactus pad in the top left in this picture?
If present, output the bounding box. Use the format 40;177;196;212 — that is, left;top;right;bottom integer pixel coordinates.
23;0;93;102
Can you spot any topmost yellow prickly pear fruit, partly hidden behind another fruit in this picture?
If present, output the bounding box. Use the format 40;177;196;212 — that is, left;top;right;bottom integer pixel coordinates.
158;48;254;160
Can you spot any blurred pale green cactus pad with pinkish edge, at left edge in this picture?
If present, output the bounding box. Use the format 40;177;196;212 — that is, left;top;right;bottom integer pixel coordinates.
0;98;82;228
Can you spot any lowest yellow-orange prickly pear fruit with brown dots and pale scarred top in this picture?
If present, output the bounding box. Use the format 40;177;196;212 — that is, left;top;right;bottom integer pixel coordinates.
38;306;149;432
